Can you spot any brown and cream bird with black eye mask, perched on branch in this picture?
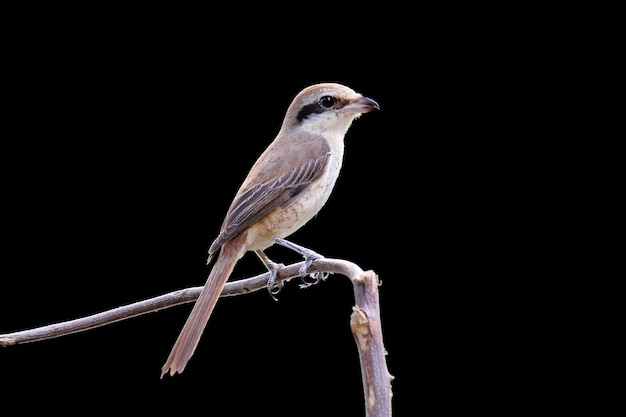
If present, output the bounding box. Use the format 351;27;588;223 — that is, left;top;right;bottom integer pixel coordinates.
161;82;380;378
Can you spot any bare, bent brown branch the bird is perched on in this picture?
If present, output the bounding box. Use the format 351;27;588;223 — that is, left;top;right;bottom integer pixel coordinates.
0;258;393;417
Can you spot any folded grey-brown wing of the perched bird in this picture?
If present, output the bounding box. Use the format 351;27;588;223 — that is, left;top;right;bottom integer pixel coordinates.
209;147;330;253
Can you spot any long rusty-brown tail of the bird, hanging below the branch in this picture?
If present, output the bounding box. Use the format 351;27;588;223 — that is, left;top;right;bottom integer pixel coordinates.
161;239;243;378
